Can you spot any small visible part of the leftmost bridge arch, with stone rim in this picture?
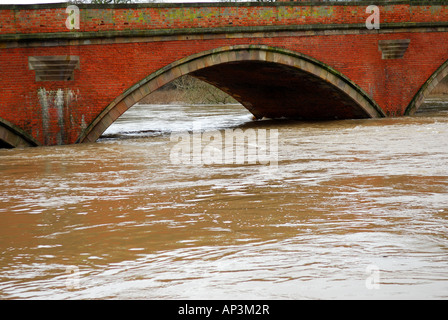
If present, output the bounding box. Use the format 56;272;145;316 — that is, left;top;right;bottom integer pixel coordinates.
0;118;40;148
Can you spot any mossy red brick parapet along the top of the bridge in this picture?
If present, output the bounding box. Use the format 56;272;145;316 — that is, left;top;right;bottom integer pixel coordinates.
0;0;448;41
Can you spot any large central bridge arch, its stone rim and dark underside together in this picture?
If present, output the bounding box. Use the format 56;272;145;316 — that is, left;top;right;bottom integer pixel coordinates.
77;45;385;143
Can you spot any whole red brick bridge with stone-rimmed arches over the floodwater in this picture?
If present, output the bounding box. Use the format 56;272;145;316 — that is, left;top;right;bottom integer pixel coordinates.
0;1;448;147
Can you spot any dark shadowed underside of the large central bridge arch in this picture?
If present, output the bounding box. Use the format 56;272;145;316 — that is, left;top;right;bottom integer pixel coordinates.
191;61;371;120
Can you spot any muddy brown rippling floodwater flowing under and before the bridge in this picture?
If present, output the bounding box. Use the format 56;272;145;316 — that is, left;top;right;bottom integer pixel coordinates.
0;101;448;299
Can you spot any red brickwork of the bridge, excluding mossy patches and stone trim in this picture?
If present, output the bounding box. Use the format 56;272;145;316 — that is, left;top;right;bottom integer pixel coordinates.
0;5;448;145
